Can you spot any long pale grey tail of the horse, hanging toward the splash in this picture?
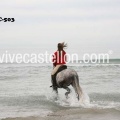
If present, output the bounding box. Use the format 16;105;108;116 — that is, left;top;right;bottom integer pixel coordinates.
73;75;83;103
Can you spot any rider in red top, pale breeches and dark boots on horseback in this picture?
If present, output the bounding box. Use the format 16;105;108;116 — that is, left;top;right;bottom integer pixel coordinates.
51;42;67;90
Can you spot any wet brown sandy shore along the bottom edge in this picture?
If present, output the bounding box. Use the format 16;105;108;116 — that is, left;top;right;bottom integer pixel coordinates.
2;109;120;120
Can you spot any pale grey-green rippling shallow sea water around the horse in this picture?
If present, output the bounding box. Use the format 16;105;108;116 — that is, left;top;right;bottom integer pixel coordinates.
0;64;120;119
